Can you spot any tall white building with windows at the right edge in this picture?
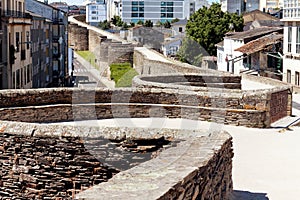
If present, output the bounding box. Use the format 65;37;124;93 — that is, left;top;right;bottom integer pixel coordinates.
282;0;300;85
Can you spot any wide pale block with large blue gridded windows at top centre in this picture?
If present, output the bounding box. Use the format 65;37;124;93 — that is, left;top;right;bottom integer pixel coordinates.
122;0;186;24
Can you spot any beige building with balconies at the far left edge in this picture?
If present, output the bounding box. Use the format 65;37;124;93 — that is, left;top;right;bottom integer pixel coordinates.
1;0;32;89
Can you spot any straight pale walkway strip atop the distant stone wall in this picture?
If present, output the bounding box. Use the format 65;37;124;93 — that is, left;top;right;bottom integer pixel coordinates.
68;16;130;43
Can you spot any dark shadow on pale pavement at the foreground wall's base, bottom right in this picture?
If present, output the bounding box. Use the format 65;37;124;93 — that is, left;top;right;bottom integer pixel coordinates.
229;190;269;200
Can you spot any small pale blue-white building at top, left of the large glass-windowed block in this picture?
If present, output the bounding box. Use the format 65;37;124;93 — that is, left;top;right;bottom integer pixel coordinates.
86;0;109;26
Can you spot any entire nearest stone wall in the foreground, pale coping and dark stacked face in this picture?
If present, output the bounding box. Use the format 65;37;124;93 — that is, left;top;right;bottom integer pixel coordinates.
0;121;233;200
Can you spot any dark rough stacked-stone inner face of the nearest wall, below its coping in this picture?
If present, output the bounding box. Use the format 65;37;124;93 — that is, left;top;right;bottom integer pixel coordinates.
0;133;176;199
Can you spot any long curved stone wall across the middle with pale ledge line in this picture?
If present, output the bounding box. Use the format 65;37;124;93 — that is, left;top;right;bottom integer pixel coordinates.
0;88;291;127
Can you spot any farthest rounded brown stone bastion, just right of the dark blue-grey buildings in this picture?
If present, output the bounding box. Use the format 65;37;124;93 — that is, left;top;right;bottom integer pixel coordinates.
68;23;90;51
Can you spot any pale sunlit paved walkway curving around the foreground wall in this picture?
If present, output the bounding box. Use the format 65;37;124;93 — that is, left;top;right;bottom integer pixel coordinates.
58;94;300;200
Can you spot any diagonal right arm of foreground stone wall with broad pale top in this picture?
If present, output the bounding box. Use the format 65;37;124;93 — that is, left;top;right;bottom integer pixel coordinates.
76;133;233;200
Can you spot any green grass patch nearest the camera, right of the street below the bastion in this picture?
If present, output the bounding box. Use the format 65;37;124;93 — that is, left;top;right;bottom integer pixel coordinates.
110;63;138;87
